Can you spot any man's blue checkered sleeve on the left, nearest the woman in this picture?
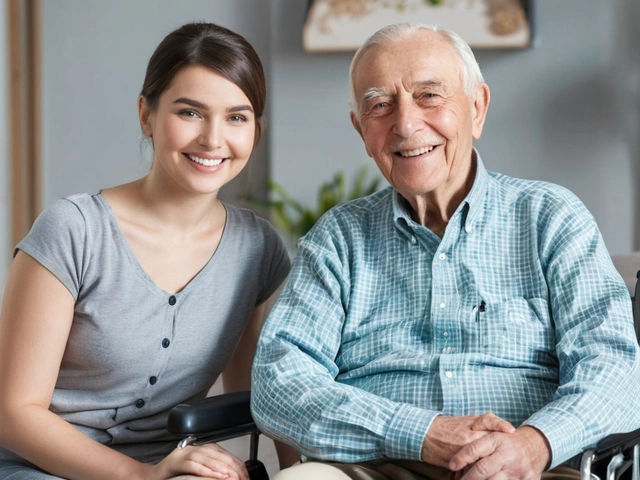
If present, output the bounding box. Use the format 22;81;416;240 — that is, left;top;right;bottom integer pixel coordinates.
252;213;437;462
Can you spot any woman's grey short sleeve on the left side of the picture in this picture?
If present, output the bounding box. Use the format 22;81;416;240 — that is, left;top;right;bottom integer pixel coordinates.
13;199;87;299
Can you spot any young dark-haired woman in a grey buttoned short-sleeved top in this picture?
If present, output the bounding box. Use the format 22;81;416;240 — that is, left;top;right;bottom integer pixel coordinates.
0;23;290;480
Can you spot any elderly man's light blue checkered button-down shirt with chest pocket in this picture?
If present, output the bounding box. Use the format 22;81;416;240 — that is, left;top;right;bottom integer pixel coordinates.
252;155;640;466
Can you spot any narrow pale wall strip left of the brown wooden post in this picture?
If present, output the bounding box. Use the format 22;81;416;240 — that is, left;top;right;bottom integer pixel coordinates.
0;0;12;292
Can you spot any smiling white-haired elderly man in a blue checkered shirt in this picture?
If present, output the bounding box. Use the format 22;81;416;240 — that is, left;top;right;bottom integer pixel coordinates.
252;24;640;480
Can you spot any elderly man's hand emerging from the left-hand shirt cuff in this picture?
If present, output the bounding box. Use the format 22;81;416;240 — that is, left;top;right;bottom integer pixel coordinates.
422;413;516;467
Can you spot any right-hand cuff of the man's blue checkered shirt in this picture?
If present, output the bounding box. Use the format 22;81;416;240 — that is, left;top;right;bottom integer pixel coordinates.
523;409;585;469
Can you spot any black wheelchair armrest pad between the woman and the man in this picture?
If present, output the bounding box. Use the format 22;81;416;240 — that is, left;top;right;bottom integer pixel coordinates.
167;392;253;435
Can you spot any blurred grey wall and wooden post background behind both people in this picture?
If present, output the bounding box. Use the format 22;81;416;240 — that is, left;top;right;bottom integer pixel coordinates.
0;0;640;287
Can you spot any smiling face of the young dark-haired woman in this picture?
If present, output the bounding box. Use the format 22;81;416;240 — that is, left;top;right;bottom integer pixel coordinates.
139;66;256;195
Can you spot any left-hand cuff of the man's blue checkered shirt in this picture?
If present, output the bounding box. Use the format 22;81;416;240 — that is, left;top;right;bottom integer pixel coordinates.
383;403;439;461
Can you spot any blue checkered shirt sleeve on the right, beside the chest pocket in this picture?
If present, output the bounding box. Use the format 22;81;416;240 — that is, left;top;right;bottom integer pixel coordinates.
525;193;640;466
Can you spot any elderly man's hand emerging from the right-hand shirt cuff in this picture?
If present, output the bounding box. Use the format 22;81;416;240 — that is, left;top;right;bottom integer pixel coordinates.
448;425;551;480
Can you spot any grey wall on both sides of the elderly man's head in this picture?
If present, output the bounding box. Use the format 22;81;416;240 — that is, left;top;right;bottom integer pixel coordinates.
270;0;640;254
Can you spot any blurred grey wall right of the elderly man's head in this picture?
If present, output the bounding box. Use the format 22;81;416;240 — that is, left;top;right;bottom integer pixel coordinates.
477;0;638;254
